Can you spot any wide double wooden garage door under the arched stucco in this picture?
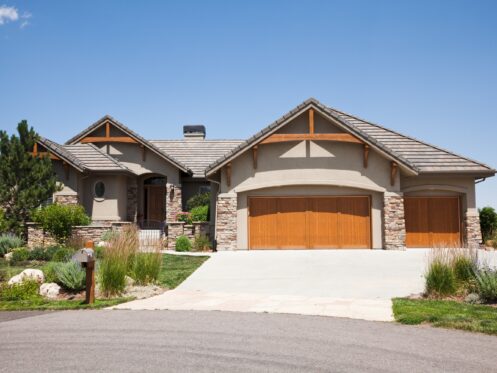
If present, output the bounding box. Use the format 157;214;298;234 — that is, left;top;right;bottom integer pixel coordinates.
249;196;371;249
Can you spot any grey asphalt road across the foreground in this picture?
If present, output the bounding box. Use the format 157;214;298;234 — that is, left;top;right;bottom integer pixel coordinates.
0;311;497;372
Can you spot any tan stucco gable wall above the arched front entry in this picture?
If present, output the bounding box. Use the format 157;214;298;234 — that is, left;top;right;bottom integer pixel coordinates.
101;143;181;186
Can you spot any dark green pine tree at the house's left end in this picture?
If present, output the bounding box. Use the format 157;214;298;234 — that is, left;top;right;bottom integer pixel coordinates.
0;120;57;236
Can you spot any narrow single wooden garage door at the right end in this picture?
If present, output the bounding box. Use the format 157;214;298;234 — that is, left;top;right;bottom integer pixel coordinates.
404;197;461;247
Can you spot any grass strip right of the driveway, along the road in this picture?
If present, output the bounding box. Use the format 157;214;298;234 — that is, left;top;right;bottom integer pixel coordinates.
393;298;497;335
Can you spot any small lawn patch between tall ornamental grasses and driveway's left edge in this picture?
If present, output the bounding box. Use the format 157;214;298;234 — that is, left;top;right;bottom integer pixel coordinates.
158;254;209;289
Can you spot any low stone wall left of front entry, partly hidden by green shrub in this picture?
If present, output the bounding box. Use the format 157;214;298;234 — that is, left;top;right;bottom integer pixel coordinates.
28;222;129;248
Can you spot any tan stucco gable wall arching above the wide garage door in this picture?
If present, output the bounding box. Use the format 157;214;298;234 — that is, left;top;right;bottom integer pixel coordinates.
222;141;400;193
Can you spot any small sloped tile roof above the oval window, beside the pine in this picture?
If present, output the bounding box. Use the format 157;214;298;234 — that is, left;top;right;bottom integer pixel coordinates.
39;137;131;172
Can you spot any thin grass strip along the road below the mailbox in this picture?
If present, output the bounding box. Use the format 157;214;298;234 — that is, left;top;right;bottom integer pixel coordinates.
0;297;133;311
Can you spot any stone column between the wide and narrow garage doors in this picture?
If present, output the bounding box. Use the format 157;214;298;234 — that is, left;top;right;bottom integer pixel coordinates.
383;192;406;250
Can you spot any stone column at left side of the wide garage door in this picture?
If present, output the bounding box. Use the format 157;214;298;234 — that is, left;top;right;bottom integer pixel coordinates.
216;194;237;251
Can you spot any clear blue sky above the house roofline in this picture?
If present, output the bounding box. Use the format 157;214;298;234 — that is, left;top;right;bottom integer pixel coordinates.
0;0;497;207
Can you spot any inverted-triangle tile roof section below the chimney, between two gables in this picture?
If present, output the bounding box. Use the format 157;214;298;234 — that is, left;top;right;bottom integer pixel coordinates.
149;138;244;177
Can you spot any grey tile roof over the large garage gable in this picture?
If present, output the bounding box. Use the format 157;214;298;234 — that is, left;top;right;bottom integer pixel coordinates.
206;98;495;176
